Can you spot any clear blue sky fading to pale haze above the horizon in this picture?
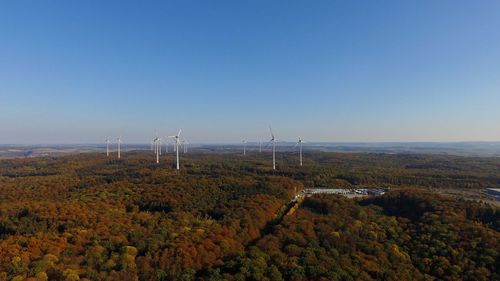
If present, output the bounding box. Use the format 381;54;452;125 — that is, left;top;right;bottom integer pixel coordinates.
0;0;500;143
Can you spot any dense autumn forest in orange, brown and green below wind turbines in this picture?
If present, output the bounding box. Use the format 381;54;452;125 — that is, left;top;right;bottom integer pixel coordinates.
0;151;500;281
